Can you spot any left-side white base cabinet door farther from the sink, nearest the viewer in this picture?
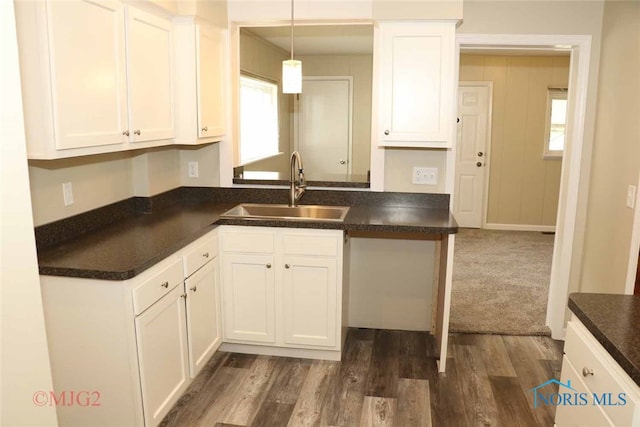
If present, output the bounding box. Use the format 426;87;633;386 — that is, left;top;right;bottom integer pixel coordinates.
135;286;189;426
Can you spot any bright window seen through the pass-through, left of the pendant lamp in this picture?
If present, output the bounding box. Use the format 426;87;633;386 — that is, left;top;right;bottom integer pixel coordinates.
240;76;279;165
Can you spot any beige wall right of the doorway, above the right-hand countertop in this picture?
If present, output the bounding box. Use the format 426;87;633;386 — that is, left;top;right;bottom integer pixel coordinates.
580;1;640;293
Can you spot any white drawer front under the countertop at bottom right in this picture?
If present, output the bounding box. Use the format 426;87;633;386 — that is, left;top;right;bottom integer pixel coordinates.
564;318;640;426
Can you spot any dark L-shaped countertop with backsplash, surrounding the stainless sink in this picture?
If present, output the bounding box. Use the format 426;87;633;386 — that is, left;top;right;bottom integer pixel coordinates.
36;188;458;280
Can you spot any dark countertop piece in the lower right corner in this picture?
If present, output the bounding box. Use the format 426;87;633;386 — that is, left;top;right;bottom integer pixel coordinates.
569;293;640;385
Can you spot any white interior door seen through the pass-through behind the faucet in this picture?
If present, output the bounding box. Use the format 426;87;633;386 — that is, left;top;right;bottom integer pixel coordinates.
294;77;353;176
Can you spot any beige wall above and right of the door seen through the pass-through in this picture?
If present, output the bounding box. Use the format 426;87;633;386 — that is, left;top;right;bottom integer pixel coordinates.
298;55;373;175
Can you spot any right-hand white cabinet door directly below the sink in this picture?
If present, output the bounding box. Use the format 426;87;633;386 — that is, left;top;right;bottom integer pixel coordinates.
283;256;339;347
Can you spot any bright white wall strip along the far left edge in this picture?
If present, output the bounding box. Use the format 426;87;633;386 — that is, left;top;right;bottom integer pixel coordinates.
0;1;57;427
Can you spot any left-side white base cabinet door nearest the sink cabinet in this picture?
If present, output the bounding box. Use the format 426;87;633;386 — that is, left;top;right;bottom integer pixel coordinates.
185;259;221;378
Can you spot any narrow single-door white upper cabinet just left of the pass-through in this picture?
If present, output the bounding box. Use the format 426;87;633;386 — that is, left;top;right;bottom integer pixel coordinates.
174;17;225;145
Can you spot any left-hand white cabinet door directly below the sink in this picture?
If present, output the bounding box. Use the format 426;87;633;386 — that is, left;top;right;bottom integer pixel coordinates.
222;253;275;343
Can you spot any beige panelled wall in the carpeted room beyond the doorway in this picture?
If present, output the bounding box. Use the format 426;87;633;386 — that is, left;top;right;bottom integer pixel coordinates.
460;55;569;229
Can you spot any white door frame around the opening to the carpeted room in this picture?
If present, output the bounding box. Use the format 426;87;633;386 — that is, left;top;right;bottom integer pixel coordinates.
445;34;591;339
